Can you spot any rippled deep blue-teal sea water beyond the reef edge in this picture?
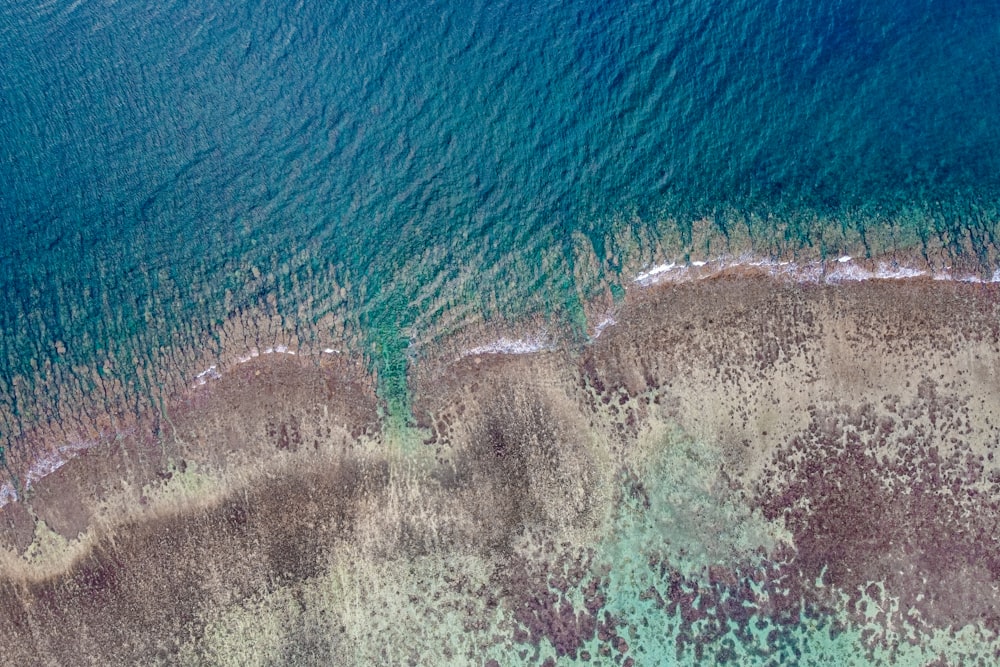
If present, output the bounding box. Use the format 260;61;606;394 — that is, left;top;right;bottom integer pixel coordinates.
0;0;1000;422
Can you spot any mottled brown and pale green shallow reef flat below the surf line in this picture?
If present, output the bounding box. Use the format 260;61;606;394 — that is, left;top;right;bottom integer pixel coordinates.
0;269;1000;665
